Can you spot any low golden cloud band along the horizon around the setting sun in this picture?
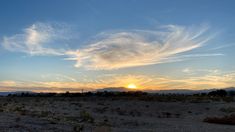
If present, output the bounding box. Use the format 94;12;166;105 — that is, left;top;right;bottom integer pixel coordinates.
0;69;235;92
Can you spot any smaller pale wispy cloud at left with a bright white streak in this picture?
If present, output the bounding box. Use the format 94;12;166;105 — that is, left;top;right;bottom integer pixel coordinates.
2;23;68;55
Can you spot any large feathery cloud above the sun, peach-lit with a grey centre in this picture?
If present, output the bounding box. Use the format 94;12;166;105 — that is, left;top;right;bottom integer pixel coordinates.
66;25;210;70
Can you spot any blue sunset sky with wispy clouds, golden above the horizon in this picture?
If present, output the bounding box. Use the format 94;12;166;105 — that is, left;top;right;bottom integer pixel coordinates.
0;0;235;92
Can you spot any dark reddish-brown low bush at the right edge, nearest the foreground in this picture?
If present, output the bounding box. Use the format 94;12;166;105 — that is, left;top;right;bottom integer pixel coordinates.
203;114;235;125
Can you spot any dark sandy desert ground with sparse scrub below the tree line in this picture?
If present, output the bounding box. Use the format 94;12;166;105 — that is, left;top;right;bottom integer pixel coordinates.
0;97;235;132
